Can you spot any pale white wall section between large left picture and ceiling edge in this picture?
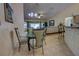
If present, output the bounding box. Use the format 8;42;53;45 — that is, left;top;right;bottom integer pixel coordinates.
11;3;24;34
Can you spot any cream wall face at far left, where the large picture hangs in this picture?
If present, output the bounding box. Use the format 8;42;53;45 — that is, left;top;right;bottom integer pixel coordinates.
0;4;14;55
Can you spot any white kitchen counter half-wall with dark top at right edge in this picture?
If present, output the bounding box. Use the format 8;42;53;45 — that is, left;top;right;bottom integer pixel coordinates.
65;27;79;56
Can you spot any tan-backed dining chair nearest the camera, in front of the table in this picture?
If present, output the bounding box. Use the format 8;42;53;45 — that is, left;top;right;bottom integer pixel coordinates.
31;30;44;55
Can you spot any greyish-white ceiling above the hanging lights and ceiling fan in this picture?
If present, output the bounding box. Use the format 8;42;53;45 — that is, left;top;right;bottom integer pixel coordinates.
24;3;72;19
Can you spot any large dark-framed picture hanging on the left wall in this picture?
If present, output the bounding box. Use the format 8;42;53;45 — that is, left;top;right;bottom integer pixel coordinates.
4;3;13;23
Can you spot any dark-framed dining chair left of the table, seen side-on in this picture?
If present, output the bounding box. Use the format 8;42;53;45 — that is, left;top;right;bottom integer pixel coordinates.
15;28;27;51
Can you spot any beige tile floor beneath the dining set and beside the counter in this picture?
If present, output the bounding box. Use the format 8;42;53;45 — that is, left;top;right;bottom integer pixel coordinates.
14;34;74;56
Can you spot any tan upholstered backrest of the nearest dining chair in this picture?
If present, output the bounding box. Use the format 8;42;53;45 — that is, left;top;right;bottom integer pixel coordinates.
34;30;44;47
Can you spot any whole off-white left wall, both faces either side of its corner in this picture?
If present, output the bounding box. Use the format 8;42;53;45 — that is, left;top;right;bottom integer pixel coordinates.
0;3;24;55
